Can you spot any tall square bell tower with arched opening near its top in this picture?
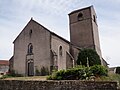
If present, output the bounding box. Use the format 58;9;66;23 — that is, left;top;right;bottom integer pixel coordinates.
69;6;102;57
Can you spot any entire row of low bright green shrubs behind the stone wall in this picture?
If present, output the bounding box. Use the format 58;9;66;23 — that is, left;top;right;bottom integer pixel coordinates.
47;65;108;80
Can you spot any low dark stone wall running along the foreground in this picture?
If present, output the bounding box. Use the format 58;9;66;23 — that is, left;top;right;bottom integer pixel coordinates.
0;80;117;90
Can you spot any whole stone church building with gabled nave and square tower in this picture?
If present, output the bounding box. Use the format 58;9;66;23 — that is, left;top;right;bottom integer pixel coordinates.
10;6;106;76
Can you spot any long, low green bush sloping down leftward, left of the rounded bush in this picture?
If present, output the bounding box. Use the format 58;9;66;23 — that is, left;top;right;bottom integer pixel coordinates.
47;66;92;80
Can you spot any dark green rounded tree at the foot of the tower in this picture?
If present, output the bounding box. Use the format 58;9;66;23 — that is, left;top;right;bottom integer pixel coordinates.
77;49;101;66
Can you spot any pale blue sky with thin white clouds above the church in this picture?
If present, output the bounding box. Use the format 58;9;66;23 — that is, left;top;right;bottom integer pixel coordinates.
0;0;120;67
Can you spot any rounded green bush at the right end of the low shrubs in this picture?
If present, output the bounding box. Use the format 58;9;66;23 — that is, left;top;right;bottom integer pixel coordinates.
90;65;108;77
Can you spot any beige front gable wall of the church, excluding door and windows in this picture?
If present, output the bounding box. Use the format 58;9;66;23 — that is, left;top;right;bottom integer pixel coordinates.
14;21;50;75
